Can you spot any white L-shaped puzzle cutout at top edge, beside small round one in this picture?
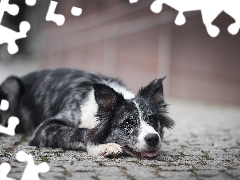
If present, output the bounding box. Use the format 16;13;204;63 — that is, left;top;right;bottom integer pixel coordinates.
46;1;65;26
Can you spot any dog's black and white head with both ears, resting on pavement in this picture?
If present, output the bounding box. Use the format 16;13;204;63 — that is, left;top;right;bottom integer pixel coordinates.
88;77;174;158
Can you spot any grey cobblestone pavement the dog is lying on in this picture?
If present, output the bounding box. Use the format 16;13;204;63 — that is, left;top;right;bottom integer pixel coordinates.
0;100;240;180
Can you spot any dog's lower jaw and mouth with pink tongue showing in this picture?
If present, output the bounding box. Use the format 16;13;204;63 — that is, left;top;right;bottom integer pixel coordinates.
123;145;158;159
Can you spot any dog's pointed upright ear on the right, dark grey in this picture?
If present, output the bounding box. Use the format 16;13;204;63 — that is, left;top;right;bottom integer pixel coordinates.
138;76;166;103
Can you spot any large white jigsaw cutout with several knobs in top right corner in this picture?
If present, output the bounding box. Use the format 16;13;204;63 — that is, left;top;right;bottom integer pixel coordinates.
151;0;240;37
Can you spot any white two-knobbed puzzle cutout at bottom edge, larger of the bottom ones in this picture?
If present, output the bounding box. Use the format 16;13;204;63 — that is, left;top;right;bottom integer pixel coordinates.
16;151;49;180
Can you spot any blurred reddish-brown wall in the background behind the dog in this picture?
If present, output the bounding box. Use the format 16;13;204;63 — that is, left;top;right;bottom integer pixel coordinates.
0;0;240;104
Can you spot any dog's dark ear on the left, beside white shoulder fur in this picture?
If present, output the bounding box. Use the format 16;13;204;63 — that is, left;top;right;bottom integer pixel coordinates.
93;83;124;111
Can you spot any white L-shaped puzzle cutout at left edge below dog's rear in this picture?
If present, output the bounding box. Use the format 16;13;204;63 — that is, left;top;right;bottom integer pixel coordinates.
0;116;20;136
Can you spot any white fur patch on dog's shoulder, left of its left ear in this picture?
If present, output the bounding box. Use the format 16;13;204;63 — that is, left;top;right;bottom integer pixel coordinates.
79;90;98;129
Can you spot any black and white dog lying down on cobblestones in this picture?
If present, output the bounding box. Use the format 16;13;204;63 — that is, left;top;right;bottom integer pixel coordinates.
0;69;174;158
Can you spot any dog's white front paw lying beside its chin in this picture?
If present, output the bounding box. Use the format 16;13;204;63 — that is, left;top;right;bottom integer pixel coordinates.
87;143;123;157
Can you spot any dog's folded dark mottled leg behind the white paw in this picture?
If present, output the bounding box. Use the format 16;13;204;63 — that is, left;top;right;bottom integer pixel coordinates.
29;119;87;150
